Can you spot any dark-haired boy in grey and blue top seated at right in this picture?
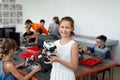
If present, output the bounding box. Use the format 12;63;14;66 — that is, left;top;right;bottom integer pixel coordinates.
87;35;111;59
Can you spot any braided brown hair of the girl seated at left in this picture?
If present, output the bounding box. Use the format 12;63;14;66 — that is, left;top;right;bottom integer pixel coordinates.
0;38;17;60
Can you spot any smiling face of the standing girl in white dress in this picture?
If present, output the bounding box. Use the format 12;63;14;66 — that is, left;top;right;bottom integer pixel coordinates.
59;20;73;38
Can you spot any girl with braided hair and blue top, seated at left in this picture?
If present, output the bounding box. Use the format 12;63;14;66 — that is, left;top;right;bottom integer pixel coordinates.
0;39;40;80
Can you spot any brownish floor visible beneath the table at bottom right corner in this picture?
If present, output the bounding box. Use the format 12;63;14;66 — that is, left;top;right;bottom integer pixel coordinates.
98;65;120;80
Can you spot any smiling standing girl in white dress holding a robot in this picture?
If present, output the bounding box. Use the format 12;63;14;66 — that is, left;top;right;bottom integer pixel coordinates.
48;17;78;80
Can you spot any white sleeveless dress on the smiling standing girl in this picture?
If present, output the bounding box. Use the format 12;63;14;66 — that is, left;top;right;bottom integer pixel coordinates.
50;40;75;80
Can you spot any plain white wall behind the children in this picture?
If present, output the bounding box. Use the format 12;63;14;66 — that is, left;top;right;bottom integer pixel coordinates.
16;0;120;60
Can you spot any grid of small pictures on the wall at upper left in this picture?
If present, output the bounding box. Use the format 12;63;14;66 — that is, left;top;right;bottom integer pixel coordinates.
0;0;23;27
